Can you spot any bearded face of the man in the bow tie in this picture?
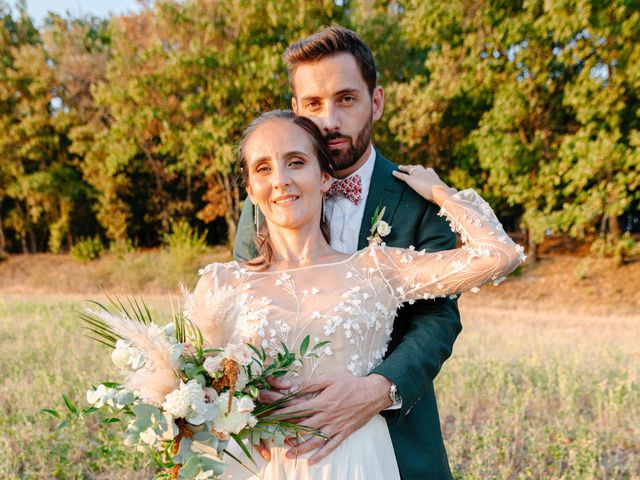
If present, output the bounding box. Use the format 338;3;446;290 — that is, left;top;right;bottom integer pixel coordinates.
292;53;384;176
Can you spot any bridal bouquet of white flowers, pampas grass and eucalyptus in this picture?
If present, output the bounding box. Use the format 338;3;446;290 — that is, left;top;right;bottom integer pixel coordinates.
44;299;328;480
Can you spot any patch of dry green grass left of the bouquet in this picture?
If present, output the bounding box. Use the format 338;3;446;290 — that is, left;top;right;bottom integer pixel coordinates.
0;295;182;480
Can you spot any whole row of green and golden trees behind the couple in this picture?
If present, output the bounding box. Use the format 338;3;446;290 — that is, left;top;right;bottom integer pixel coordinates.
0;0;640;260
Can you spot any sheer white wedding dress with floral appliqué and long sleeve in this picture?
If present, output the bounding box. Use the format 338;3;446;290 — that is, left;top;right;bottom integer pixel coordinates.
188;190;524;480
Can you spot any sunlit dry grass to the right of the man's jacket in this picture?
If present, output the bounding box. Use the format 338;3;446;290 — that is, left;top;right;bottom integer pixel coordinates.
436;293;640;479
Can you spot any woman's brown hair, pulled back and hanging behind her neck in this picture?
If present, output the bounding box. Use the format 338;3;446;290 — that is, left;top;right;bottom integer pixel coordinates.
238;110;333;270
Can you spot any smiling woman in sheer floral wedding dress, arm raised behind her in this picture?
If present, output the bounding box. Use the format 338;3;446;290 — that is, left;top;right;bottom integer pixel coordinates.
191;110;524;480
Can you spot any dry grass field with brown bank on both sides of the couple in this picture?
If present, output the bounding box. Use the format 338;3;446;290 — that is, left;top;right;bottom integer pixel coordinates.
0;253;640;480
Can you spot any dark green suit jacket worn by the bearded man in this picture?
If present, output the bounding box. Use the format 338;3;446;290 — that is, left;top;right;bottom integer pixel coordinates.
234;153;462;480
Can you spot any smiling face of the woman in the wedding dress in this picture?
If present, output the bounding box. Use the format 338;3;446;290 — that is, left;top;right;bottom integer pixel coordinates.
244;119;332;229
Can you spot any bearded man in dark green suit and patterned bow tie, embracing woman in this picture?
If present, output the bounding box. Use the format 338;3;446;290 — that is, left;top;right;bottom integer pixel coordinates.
234;26;462;480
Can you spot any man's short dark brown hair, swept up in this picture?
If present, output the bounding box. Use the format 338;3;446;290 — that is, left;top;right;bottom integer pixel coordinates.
282;24;376;95
